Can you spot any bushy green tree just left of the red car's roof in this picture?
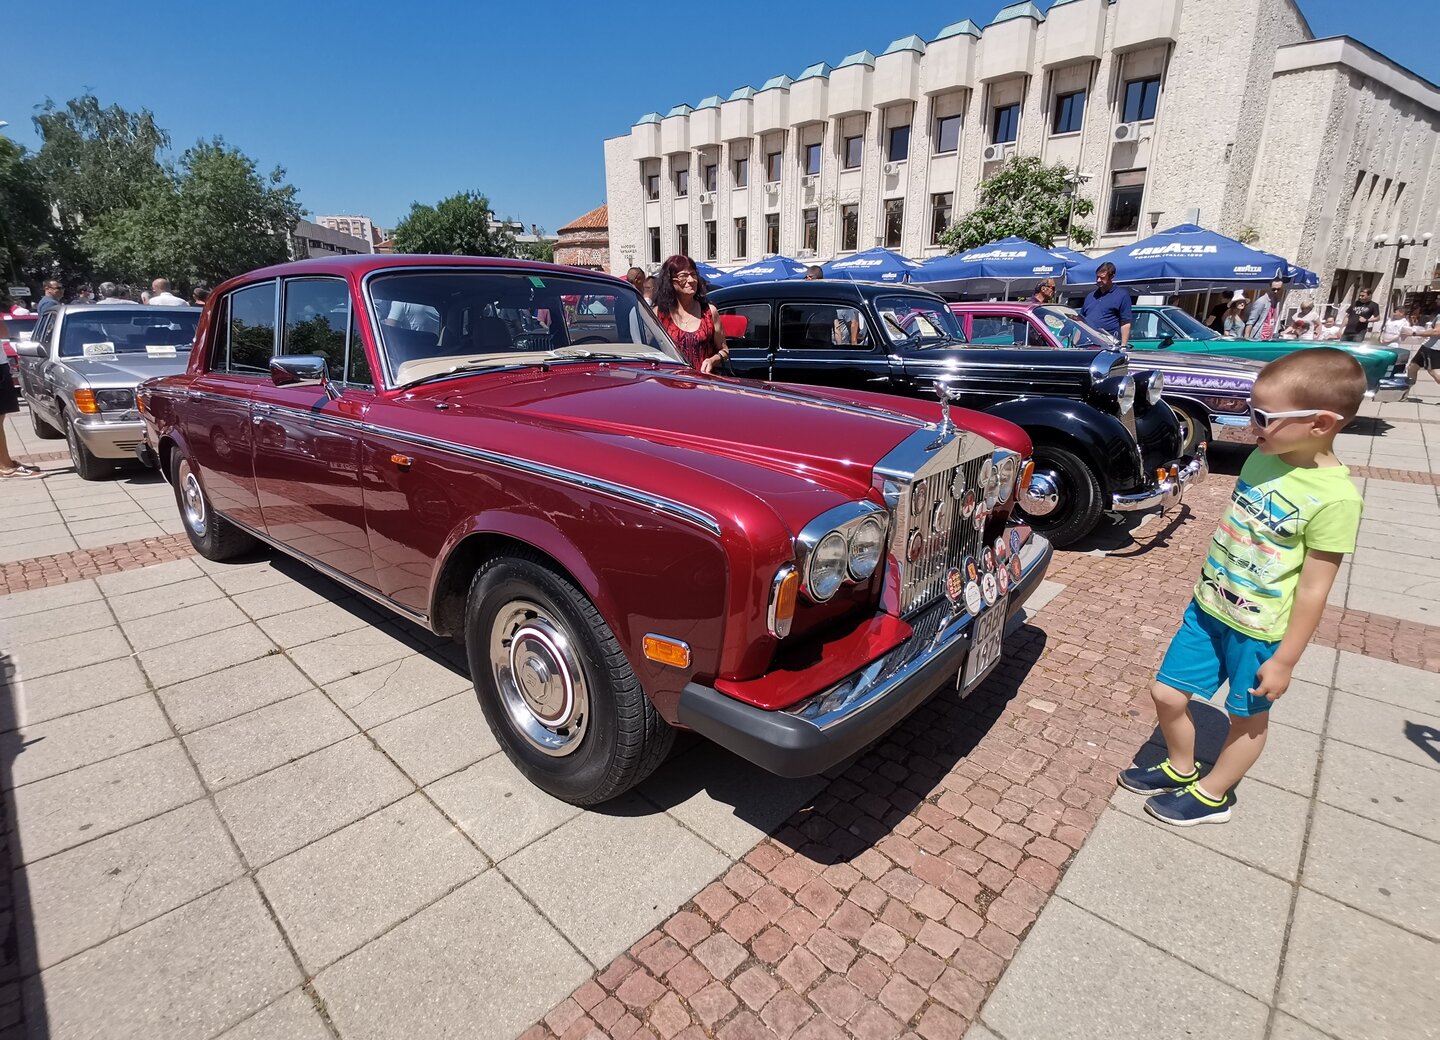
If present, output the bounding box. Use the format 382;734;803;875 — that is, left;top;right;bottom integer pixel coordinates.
85;138;301;285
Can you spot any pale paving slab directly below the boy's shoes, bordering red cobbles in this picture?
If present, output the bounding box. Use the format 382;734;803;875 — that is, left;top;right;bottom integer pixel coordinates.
1056;812;1293;1001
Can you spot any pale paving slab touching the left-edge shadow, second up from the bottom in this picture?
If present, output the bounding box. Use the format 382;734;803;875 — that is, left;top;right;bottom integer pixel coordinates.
16;801;243;968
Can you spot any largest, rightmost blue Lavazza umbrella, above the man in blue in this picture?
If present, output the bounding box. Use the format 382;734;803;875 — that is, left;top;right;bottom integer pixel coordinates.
1067;223;1290;291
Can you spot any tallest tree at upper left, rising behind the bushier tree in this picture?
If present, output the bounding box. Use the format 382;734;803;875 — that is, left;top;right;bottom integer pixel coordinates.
33;94;170;230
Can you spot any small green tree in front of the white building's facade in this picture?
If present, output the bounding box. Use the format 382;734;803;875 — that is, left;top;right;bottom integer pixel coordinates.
940;156;1094;252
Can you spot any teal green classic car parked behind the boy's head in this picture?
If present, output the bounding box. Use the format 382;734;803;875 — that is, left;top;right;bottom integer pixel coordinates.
1130;305;1410;402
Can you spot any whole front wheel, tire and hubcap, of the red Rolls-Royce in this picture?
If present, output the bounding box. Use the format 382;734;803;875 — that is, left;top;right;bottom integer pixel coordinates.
465;552;675;805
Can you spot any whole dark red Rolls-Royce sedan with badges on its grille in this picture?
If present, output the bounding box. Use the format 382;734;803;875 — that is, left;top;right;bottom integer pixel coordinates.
140;256;1051;805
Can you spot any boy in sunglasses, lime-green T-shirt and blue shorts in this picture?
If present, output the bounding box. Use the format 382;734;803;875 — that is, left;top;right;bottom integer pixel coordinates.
1119;347;1365;827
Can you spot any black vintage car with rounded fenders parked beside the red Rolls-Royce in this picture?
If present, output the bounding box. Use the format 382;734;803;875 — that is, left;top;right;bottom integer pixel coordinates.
710;281;1208;546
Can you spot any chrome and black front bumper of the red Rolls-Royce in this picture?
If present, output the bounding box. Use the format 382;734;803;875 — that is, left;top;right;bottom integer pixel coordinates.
680;534;1054;776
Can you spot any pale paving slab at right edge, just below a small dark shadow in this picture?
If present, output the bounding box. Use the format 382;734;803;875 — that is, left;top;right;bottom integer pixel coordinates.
1319;740;1440;841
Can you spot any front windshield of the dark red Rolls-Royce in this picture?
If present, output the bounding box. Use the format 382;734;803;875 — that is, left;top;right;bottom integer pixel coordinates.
366;268;684;386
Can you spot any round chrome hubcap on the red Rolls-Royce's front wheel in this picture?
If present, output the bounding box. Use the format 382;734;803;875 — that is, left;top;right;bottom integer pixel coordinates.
490;599;590;758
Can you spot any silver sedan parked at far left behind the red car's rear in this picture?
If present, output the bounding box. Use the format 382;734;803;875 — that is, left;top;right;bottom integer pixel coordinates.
14;304;200;480
